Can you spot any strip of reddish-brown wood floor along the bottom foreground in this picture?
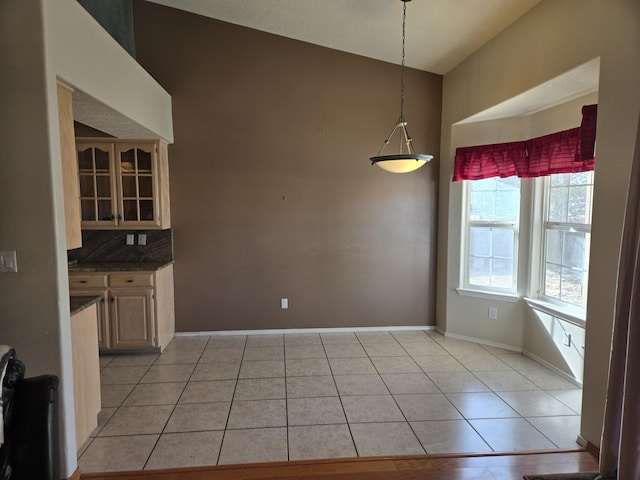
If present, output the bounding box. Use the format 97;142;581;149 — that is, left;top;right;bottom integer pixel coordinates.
81;450;598;480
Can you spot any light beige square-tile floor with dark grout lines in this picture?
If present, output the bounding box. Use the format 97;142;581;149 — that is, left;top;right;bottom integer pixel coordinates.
79;331;582;472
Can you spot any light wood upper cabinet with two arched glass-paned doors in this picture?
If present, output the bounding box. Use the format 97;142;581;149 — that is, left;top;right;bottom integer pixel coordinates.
76;138;171;229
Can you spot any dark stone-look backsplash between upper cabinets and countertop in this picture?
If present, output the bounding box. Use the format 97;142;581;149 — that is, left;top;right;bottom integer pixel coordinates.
67;228;173;263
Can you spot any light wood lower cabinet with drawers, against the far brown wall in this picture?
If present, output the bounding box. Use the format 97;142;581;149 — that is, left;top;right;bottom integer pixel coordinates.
69;265;175;352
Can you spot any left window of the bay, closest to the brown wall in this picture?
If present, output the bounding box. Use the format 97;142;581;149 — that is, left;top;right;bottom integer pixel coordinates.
464;176;520;293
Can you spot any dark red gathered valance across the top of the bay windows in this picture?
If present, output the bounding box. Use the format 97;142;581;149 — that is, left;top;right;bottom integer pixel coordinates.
453;105;598;182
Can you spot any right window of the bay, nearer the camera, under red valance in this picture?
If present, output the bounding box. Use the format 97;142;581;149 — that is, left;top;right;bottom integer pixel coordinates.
541;171;593;308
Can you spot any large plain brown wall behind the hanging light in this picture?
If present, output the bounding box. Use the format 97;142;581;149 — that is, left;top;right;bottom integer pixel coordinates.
134;1;442;331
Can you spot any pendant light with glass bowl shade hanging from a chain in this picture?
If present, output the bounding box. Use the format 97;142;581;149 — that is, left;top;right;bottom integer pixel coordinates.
369;0;433;173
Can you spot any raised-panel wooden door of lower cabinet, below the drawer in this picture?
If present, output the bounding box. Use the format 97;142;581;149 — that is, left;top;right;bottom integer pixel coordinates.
109;289;154;349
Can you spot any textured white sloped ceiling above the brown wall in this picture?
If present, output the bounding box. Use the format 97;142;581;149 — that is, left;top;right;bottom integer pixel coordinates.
144;0;540;75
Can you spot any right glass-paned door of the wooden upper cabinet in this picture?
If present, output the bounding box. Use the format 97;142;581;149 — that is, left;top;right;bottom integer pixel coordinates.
116;144;157;224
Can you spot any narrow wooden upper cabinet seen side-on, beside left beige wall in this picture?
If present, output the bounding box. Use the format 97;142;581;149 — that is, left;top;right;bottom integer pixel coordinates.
58;82;82;250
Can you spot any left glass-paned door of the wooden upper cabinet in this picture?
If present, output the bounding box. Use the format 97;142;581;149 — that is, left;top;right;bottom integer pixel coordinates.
76;143;117;225
